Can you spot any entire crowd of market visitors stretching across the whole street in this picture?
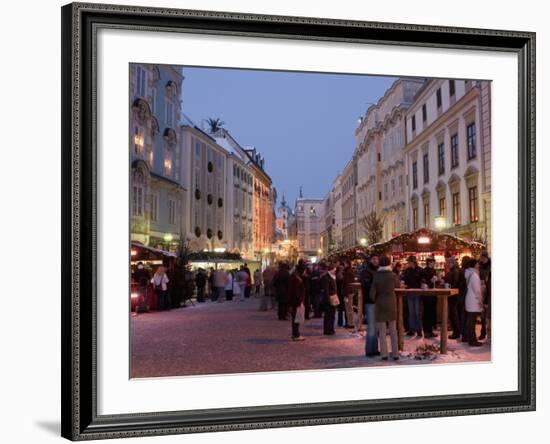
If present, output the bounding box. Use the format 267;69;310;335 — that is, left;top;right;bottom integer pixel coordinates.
132;251;491;360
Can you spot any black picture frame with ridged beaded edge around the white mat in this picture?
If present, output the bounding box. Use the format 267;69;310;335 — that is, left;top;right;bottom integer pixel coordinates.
61;3;535;440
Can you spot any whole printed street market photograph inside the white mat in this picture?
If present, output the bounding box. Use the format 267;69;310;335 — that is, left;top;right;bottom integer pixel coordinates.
130;65;496;379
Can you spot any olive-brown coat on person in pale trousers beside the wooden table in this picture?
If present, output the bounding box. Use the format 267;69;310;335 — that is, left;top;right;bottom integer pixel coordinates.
369;267;398;322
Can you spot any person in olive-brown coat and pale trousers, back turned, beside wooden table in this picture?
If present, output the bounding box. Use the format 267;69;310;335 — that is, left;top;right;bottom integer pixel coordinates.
369;256;399;360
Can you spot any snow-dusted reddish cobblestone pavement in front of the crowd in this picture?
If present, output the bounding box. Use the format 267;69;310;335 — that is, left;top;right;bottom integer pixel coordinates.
131;298;490;378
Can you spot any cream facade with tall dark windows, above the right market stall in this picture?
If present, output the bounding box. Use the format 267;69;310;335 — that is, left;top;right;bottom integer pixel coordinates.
405;79;490;248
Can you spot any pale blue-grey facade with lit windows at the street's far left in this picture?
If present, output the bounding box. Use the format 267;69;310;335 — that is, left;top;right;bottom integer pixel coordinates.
129;64;186;250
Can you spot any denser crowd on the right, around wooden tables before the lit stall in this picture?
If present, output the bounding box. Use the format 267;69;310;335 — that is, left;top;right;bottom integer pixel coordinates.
261;251;491;359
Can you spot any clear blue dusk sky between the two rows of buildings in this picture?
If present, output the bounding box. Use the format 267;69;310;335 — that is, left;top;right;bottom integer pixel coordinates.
183;68;395;207
